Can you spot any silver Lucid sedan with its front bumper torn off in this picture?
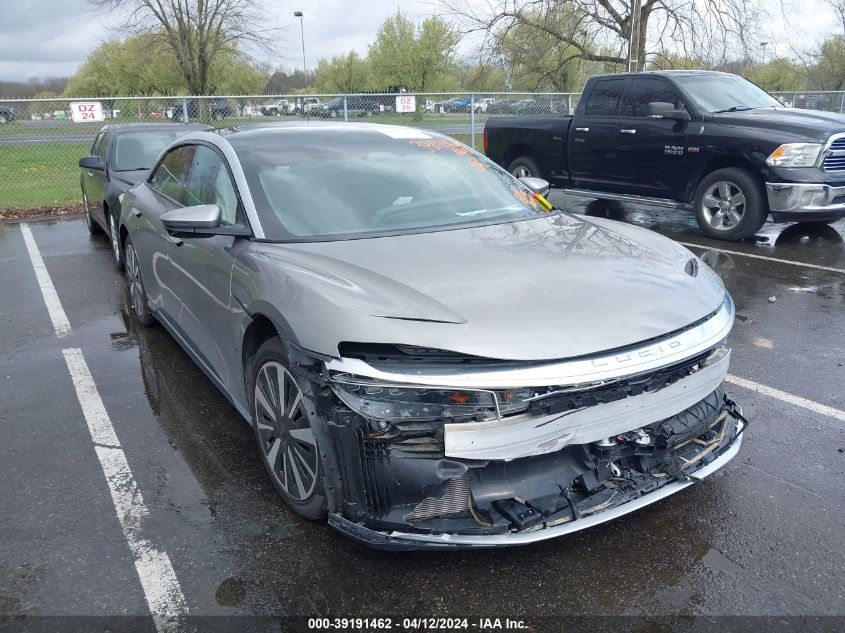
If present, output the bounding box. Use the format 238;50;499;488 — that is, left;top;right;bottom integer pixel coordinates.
115;122;746;549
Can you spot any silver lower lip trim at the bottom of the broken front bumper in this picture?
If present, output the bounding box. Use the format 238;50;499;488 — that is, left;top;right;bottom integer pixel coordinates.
379;420;744;547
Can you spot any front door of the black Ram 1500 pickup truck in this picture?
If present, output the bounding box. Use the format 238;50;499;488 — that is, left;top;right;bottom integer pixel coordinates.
616;76;698;199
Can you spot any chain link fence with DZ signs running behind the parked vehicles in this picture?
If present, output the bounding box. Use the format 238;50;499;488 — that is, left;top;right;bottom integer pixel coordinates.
0;87;845;209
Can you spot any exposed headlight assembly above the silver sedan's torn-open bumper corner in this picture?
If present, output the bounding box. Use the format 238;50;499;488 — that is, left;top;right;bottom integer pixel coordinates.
333;376;534;421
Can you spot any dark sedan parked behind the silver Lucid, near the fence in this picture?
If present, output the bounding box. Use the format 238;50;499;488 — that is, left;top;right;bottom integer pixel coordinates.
79;123;212;268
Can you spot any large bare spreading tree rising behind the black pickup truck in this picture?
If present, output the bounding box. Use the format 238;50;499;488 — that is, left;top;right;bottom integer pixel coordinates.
435;0;766;70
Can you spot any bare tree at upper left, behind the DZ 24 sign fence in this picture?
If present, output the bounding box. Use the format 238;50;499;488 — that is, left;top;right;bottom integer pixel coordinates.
88;0;277;95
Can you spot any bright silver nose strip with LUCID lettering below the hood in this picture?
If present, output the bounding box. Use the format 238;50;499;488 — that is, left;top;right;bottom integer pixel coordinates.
326;294;734;390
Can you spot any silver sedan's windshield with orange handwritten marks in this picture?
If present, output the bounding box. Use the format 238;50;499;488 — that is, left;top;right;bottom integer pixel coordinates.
231;124;548;241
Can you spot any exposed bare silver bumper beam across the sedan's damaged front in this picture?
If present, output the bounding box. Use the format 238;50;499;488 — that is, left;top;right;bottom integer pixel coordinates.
443;347;731;460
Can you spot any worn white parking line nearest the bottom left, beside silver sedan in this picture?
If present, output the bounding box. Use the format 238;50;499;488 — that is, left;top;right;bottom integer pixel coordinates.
62;348;186;633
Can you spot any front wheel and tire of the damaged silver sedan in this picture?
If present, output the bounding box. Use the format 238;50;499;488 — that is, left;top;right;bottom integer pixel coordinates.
247;337;328;520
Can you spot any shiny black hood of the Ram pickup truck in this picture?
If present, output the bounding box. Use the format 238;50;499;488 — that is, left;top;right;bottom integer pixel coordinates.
713;108;845;143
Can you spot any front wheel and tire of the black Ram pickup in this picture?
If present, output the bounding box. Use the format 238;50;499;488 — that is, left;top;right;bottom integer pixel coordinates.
693;167;769;241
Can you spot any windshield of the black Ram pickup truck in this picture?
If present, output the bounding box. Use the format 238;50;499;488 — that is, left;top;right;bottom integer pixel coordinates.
675;75;783;112
